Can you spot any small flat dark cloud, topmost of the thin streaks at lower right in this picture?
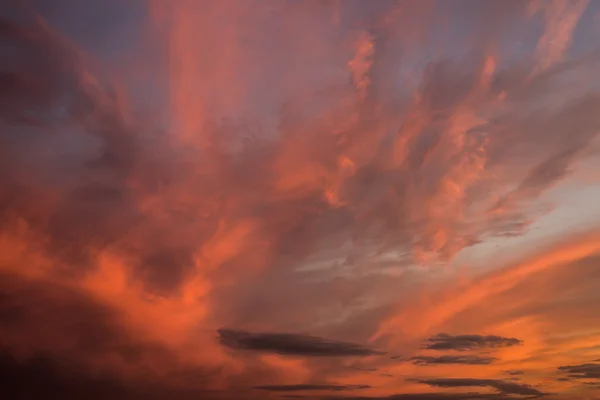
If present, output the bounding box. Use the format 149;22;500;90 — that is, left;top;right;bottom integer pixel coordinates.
425;333;522;351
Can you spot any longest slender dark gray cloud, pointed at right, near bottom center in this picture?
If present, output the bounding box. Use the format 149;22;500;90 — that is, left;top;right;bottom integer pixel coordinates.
218;329;384;357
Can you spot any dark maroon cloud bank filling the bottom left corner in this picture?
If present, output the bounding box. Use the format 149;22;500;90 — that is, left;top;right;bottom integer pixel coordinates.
0;273;214;399
